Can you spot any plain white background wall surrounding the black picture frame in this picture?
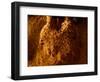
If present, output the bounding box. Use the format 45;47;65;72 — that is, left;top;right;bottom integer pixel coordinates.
0;0;100;82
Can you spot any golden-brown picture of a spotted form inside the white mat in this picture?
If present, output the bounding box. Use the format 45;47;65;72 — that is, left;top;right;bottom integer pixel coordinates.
28;15;88;66
